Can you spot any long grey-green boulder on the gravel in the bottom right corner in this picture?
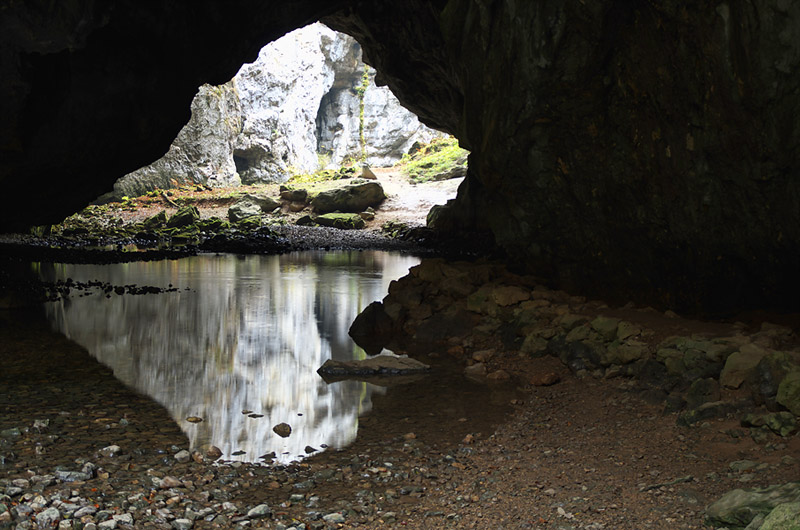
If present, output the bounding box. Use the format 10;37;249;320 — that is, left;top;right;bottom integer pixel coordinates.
706;482;800;530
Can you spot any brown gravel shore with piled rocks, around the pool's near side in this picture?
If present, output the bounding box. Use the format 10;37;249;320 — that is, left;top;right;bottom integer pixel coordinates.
0;240;800;530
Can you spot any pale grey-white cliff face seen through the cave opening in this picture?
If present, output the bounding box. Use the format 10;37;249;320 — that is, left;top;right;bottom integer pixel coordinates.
107;23;442;198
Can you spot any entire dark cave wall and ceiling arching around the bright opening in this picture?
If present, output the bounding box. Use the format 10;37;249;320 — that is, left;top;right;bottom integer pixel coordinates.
0;0;800;312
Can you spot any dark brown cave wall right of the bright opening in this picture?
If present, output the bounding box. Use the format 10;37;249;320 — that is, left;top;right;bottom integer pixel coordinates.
327;0;800;313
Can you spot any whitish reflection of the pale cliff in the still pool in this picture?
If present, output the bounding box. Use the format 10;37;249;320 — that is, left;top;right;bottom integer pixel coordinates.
40;252;418;462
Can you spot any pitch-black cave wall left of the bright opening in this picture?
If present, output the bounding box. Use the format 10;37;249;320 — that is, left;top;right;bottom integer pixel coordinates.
0;0;348;231
